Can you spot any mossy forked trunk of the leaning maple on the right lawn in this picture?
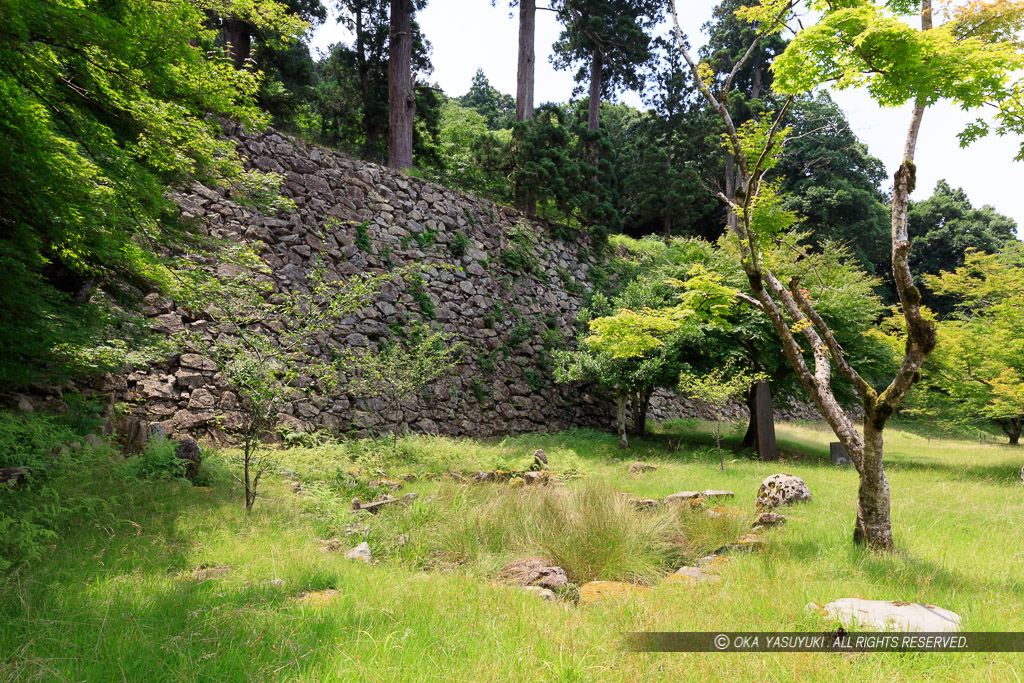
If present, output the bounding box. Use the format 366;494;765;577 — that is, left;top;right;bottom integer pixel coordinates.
672;0;935;551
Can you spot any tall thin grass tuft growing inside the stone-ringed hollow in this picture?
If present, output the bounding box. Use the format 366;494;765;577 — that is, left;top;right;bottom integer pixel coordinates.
419;482;736;584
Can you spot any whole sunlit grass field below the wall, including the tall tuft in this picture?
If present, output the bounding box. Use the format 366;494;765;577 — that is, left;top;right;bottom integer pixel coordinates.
0;424;1024;682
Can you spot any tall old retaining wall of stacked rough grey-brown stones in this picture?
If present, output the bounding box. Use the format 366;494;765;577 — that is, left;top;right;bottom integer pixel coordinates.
97;127;823;436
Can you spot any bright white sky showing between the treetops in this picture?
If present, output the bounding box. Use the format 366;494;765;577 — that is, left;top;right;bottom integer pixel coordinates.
312;0;1024;236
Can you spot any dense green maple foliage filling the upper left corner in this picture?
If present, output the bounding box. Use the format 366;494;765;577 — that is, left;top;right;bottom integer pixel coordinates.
0;0;305;388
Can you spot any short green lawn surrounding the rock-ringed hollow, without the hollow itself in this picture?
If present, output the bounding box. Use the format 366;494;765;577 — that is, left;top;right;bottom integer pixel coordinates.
0;426;1024;681
